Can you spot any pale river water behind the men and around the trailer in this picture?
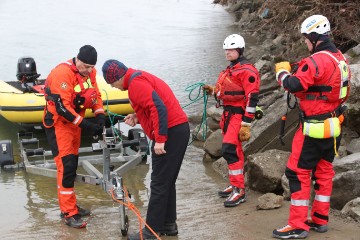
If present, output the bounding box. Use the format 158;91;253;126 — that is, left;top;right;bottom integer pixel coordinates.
0;0;242;239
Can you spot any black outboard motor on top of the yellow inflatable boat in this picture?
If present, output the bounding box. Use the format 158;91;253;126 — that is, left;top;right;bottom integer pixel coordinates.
16;57;40;83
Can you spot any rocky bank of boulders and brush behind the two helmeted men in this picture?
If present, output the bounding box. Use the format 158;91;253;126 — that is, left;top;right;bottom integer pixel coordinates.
193;0;360;221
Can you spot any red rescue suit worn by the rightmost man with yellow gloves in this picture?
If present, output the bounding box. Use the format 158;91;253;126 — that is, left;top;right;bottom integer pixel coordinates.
279;42;350;231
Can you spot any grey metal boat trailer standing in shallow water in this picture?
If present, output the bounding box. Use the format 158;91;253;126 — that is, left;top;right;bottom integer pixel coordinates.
5;124;148;236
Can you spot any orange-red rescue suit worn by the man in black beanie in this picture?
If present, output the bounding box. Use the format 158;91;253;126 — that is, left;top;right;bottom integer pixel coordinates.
43;59;104;217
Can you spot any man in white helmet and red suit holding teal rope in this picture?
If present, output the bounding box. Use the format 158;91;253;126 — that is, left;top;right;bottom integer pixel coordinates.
203;34;260;207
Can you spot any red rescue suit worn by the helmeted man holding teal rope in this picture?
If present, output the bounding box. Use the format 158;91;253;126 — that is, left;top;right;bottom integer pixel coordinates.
215;57;260;188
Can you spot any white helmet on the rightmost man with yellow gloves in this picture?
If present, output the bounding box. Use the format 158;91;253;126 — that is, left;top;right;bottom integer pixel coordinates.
301;15;330;35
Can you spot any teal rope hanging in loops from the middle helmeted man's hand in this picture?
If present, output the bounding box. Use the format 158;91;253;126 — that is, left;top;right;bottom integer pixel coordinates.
182;82;209;145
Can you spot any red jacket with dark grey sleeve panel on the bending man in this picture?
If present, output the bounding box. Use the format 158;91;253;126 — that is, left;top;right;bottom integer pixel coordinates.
124;68;188;143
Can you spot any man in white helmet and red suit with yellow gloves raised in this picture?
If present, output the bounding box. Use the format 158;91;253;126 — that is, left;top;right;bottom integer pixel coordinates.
273;15;350;239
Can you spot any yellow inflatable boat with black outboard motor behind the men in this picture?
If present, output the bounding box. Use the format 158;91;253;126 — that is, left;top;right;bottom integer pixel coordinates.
0;57;134;126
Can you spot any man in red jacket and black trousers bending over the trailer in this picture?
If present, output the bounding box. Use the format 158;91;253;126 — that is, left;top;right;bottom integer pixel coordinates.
102;59;190;240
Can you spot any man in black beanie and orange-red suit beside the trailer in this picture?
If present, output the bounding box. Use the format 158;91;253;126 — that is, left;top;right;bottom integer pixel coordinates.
43;45;105;228
